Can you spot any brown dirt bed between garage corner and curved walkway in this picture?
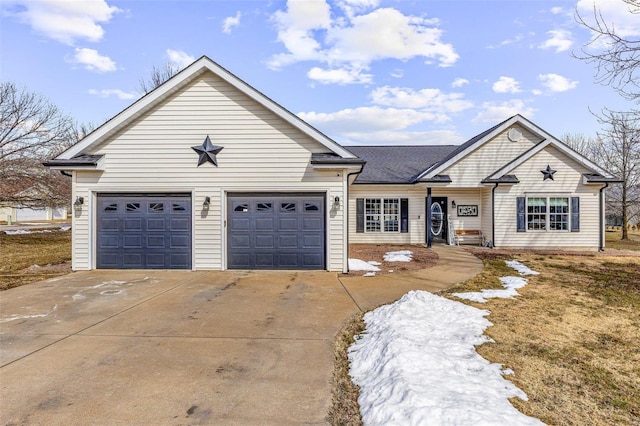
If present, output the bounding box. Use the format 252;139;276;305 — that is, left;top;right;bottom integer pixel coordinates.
347;244;438;275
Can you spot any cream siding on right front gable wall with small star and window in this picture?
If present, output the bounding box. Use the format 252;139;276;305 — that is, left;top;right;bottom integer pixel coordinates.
495;147;600;249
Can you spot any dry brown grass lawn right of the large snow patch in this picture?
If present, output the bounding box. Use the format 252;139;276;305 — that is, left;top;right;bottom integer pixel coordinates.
450;251;640;425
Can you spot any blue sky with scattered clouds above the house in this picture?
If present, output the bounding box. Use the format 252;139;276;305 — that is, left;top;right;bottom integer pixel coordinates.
0;0;640;144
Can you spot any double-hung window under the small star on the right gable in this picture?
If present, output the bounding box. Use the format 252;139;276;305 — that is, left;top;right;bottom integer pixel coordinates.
522;195;578;231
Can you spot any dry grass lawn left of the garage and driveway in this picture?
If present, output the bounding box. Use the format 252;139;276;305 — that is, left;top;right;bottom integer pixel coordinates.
0;230;71;290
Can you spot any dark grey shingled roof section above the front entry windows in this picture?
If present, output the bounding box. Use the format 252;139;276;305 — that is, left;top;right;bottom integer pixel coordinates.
349;145;458;184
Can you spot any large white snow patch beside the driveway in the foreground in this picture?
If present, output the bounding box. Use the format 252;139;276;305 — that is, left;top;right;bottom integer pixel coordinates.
349;291;543;425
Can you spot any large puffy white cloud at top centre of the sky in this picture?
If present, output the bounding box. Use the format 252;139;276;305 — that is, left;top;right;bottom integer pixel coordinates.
268;0;459;82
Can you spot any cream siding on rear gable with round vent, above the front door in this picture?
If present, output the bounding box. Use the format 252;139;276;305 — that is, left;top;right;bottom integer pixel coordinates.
442;125;540;188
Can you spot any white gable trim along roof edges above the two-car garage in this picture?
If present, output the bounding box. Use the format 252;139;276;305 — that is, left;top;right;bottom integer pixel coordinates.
52;56;356;162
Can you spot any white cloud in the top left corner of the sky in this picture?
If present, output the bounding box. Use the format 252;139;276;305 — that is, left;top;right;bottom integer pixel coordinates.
8;0;122;45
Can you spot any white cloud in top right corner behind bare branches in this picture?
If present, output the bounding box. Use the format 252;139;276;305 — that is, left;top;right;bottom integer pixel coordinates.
576;0;640;37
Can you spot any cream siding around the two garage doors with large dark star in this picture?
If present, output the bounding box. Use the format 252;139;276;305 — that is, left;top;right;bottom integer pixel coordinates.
74;73;345;271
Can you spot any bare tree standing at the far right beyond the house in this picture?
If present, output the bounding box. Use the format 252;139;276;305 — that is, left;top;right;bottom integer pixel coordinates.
591;109;640;240
